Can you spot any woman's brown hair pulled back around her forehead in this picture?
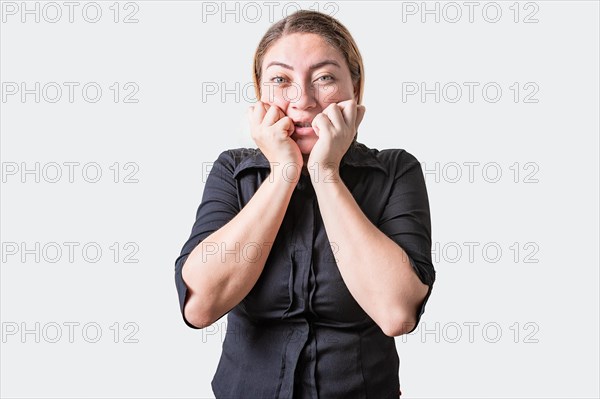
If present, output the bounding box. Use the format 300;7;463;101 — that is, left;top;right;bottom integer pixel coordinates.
253;10;364;104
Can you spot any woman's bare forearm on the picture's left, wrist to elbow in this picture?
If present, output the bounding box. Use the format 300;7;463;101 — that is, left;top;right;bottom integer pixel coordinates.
182;173;296;328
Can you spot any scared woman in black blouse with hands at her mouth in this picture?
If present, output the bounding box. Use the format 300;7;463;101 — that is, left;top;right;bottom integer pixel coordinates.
175;11;435;399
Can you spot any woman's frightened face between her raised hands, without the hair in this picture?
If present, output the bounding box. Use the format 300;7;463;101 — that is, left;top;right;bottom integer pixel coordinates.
260;33;356;155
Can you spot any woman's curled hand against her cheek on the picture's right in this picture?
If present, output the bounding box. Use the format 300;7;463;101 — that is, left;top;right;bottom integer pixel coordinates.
307;99;366;178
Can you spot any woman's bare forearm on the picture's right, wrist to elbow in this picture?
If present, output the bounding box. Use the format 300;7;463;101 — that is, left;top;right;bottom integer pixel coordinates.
314;169;428;336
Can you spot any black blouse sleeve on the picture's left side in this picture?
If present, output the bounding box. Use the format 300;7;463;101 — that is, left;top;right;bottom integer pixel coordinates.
175;151;240;329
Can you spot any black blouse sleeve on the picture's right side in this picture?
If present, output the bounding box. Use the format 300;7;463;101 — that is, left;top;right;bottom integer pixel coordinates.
378;150;435;333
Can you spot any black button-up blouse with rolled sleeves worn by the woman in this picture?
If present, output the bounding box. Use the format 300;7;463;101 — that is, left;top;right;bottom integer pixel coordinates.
175;142;435;399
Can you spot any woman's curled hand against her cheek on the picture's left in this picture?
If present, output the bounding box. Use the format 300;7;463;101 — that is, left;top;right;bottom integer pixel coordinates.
248;101;303;177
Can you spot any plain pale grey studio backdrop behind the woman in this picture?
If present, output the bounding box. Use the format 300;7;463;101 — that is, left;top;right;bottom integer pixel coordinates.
0;1;599;398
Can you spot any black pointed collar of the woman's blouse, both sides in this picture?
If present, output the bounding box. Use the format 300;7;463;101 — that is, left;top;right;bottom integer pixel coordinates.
233;141;388;178
